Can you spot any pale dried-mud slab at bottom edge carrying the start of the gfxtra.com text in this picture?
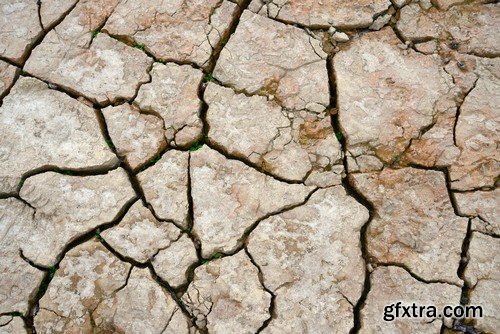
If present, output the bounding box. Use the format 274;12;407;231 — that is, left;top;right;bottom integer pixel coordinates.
360;266;461;334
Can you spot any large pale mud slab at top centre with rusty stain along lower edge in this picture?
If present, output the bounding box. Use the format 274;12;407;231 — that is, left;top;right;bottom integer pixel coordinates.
214;10;330;110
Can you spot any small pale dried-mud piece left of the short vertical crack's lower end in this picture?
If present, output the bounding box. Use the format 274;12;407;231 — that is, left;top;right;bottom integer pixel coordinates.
151;234;198;289
